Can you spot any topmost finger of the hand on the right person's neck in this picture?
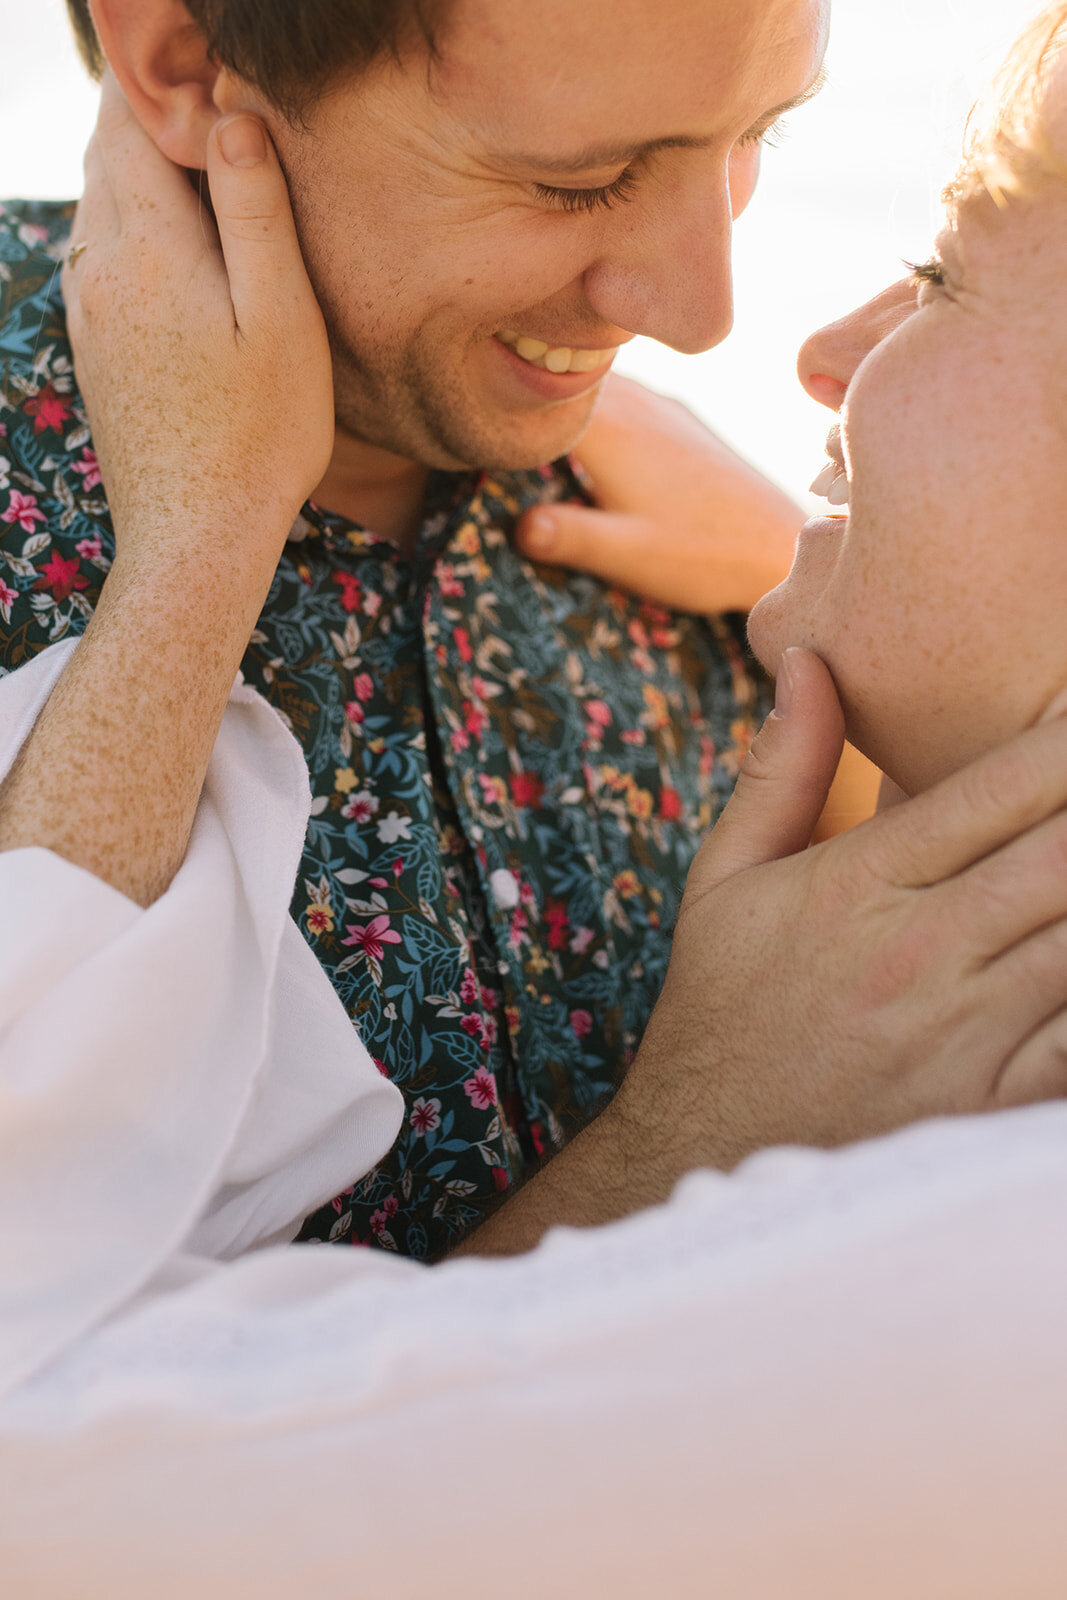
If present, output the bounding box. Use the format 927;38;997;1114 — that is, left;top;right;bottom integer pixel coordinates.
851;717;1067;888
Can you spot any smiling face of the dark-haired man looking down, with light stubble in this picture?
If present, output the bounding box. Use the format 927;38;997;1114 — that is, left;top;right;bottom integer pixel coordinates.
230;0;829;467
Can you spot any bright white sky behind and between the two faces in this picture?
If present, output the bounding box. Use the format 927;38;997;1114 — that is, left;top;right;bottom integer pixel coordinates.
0;0;1038;499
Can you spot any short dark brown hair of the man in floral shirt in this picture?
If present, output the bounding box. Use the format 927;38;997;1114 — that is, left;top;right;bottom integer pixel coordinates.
67;0;446;117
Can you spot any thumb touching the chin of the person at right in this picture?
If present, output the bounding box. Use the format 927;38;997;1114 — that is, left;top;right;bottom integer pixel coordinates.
694;650;845;890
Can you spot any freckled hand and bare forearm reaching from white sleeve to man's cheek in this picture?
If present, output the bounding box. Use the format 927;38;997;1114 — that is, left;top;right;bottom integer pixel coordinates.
0;80;333;906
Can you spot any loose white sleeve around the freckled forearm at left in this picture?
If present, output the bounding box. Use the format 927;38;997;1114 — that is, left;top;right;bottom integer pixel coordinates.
0;643;402;1392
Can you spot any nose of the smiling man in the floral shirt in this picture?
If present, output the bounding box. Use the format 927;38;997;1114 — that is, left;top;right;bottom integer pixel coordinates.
584;179;734;355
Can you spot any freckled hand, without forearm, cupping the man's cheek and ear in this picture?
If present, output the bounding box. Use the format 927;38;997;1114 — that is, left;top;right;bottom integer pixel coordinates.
62;75;333;588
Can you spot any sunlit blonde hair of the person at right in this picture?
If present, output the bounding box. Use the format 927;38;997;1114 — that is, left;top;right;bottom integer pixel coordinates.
945;0;1067;208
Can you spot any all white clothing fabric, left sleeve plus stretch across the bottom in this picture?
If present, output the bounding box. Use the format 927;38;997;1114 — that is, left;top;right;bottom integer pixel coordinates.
0;643;1067;1600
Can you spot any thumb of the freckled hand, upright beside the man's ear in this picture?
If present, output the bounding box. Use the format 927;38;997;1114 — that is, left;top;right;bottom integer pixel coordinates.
208;112;322;326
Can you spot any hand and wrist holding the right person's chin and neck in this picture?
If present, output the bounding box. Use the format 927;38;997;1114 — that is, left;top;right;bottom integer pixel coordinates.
467;650;1067;1253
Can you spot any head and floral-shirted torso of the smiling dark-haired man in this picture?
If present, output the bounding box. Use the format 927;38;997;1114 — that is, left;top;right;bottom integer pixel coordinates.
3;0;825;1256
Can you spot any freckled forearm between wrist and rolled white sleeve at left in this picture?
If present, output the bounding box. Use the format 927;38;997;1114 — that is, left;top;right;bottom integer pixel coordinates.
0;555;279;906
